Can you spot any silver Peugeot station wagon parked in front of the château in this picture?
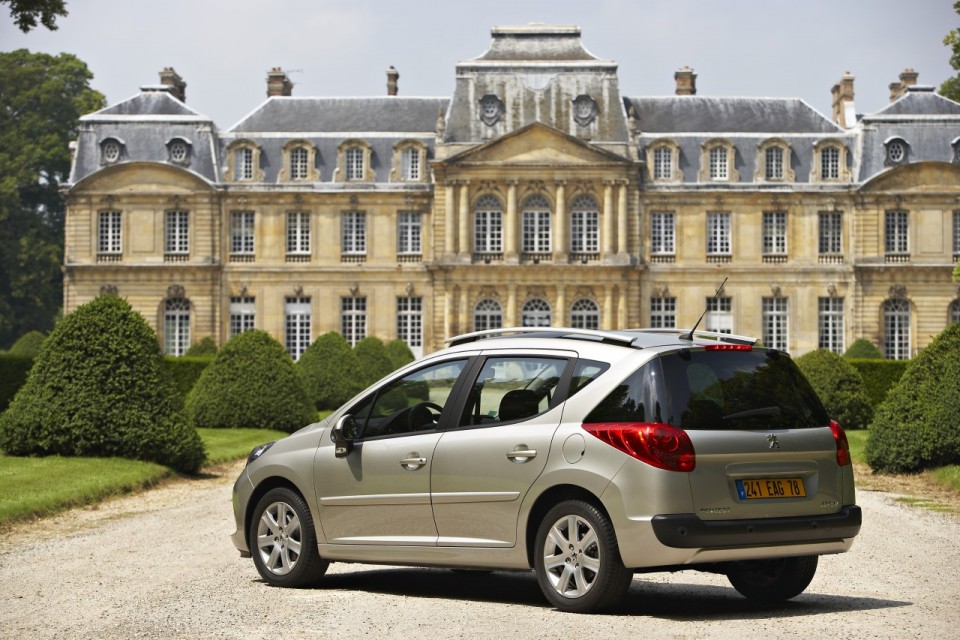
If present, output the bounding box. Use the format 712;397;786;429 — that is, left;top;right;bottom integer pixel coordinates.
232;328;861;612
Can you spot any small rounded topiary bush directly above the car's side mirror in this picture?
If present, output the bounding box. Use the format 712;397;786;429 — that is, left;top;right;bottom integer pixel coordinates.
297;331;365;410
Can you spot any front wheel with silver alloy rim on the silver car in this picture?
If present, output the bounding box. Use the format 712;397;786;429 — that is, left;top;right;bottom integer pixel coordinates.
249;487;330;587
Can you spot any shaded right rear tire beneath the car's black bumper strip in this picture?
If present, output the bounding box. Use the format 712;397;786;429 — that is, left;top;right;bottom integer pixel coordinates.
727;556;817;602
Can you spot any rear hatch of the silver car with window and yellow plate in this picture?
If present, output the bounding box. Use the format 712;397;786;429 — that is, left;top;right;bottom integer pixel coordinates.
655;345;843;520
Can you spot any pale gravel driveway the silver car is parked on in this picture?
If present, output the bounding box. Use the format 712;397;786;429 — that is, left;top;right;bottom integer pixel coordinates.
0;460;960;640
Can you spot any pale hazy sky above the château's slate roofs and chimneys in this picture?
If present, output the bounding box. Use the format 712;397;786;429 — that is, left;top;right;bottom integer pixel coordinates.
0;0;960;129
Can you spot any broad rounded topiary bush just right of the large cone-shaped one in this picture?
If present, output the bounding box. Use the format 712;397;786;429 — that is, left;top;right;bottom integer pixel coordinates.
186;331;315;433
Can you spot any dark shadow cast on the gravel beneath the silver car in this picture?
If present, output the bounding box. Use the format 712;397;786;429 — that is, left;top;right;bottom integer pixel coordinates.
284;567;913;621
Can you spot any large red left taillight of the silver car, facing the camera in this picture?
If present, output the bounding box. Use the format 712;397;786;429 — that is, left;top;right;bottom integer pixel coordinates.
583;422;697;472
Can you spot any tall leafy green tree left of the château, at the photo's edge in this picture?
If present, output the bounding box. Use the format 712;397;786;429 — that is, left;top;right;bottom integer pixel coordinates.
0;49;105;348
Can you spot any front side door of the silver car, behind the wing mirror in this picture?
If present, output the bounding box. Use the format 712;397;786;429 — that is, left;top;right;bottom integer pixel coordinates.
314;357;469;545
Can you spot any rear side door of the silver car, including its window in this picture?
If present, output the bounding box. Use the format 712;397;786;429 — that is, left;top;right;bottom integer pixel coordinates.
430;352;575;547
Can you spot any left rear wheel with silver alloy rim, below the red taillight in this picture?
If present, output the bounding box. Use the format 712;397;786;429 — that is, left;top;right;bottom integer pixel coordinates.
534;500;633;613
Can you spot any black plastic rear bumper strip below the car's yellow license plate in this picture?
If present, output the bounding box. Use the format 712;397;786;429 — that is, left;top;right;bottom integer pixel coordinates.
651;505;862;549
